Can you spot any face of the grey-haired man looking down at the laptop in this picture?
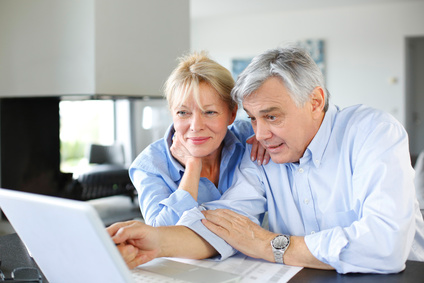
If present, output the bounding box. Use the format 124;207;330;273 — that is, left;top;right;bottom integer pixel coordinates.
243;77;324;163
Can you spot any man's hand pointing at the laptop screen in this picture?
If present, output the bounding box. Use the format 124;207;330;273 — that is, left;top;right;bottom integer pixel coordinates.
106;221;160;269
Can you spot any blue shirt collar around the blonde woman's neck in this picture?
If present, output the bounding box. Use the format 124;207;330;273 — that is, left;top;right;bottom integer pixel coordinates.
163;124;243;181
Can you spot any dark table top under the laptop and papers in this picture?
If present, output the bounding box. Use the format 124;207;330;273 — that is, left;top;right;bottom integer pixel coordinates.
0;234;424;283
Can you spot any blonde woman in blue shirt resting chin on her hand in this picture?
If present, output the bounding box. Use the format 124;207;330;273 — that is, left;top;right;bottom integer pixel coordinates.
129;53;269;226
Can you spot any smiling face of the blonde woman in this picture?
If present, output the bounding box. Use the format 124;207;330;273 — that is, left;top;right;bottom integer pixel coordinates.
171;83;237;157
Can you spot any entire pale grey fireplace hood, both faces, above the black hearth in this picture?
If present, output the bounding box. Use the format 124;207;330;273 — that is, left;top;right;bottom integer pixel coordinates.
0;0;190;97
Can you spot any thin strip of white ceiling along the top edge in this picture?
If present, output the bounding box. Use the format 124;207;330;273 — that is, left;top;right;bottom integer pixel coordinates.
190;0;423;19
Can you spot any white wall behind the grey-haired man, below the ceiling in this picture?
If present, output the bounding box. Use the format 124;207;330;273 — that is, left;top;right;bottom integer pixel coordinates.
191;1;424;123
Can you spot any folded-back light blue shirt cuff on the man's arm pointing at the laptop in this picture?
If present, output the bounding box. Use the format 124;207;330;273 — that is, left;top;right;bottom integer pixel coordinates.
176;208;237;260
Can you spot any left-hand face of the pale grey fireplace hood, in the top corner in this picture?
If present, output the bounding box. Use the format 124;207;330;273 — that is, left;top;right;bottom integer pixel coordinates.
0;0;95;96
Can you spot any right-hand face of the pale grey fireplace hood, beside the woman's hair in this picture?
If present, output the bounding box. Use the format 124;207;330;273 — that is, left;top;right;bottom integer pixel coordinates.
95;0;190;96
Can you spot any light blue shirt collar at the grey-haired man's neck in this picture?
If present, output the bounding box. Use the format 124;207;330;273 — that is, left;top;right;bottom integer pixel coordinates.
302;103;339;167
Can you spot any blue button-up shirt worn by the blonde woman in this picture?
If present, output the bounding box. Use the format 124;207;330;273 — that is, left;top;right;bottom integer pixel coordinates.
129;120;254;226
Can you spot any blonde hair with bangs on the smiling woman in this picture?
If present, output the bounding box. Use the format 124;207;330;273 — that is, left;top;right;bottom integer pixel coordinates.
164;51;237;110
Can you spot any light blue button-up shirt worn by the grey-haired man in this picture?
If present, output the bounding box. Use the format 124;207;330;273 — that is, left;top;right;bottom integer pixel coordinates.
177;105;424;273
